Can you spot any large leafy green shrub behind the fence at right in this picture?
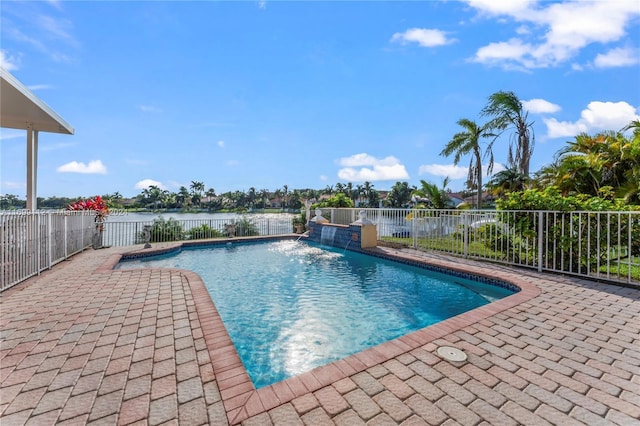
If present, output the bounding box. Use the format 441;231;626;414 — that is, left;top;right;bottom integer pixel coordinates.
492;186;640;271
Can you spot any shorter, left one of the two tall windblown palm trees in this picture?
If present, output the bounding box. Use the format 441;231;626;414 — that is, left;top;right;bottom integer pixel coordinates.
440;118;495;209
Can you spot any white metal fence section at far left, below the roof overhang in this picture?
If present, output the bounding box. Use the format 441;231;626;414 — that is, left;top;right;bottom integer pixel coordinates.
0;211;98;291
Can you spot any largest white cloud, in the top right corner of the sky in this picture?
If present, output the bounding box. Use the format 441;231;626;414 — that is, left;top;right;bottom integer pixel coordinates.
469;0;640;69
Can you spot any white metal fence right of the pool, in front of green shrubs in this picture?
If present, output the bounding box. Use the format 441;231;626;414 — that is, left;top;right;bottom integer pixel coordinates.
322;209;640;286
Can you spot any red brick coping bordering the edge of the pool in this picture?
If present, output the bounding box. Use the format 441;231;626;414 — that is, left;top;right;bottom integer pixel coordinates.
96;240;541;424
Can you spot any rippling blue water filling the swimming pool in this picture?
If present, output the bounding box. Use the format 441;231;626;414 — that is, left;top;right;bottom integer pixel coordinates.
119;240;513;388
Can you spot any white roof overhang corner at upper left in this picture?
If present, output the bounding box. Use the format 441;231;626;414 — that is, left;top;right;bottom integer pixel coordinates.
0;68;74;135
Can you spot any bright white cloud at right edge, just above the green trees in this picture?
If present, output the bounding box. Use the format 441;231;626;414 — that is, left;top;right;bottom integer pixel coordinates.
543;101;640;138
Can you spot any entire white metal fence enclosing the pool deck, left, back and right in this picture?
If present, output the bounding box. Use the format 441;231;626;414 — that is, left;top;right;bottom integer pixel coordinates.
0;209;640;291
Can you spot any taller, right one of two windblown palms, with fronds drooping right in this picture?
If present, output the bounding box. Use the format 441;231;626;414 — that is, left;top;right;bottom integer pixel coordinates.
481;91;535;178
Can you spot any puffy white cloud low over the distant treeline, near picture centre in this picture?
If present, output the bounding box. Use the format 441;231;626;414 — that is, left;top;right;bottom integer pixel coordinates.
336;153;409;182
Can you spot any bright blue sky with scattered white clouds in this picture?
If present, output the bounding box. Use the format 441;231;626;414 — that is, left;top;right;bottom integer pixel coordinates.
0;0;640;197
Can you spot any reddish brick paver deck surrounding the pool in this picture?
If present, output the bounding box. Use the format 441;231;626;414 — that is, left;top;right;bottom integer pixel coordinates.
0;241;640;426
